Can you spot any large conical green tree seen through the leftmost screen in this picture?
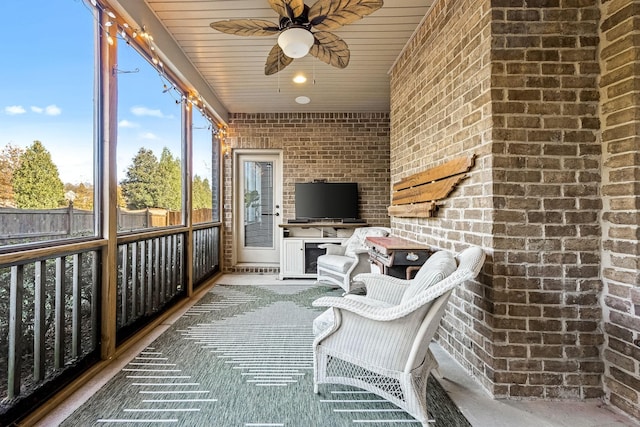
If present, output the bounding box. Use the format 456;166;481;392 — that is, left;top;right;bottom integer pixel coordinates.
13;141;64;209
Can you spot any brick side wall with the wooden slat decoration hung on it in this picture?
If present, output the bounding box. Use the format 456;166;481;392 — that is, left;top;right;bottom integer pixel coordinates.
391;0;493;390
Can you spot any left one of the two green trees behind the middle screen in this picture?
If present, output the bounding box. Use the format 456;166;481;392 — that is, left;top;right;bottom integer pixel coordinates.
120;147;161;209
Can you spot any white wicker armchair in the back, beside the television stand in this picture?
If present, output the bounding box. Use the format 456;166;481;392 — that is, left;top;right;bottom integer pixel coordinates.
317;227;390;292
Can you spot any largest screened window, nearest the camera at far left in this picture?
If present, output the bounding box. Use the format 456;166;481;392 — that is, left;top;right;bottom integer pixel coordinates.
0;0;96;247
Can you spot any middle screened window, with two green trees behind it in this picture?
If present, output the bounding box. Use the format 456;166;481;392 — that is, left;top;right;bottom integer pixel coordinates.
115;42;183;231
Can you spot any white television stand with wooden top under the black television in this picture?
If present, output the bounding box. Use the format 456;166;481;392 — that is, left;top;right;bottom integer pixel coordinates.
279;221;367;279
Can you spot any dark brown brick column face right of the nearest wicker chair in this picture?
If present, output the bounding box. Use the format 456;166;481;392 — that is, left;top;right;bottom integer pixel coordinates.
491;0;603;398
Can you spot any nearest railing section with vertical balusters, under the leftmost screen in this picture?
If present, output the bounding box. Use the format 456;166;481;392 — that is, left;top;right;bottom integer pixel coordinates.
0;242;100;409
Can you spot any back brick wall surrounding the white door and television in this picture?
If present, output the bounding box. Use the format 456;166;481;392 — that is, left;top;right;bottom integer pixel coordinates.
224;113;390;271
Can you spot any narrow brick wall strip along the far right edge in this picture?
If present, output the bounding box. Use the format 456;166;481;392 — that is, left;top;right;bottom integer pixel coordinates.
600;0;640;419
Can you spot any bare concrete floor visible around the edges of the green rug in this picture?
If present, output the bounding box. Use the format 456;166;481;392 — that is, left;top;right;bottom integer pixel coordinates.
35;274;640;427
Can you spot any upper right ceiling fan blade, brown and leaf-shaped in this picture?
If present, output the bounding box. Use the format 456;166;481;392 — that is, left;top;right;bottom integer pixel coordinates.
309;0;383;30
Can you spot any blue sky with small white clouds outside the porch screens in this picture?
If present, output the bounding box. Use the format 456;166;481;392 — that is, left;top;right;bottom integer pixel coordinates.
0;0;211;183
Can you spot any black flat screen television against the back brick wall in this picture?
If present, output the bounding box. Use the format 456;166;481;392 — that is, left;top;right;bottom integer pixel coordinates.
295;182;359;220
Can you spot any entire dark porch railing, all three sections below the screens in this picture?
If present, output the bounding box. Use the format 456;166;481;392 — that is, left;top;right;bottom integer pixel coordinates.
0;223;221;425
